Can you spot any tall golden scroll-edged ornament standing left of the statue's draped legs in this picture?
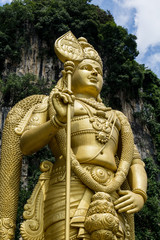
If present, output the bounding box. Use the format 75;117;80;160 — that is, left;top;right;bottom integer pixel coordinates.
20;161;53;240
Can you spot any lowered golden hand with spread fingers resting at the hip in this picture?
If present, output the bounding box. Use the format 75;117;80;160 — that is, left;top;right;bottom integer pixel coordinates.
114;190;144;213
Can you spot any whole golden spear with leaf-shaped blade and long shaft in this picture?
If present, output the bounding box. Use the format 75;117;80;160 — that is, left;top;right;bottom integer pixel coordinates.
55;31;83;240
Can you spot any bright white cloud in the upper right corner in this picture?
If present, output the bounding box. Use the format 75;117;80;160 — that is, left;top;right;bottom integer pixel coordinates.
113;0;160;54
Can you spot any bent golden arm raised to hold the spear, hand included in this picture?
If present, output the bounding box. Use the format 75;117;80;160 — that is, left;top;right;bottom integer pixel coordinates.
20;90;74;155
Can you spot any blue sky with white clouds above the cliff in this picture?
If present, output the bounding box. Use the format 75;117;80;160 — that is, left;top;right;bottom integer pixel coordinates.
0;0;160;78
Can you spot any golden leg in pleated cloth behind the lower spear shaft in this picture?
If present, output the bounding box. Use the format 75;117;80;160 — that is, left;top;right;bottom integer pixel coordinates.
44;173;86;240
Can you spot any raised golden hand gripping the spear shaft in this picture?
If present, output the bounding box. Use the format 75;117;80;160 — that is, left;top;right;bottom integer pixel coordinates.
52;89;75;123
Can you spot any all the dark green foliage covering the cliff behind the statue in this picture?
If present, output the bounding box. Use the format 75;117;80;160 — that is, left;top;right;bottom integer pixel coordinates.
0;0;160;240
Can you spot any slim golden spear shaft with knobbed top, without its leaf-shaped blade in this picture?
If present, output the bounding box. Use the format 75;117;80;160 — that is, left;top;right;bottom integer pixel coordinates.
64;61;74;240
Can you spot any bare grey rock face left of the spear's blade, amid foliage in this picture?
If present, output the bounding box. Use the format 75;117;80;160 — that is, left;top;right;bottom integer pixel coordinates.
3;35;60;81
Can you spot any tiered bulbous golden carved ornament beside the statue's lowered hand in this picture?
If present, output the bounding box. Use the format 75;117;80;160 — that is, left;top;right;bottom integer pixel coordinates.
85;192;119;240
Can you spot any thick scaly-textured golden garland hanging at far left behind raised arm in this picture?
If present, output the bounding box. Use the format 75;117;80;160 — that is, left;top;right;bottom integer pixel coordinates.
0;95;45;240
